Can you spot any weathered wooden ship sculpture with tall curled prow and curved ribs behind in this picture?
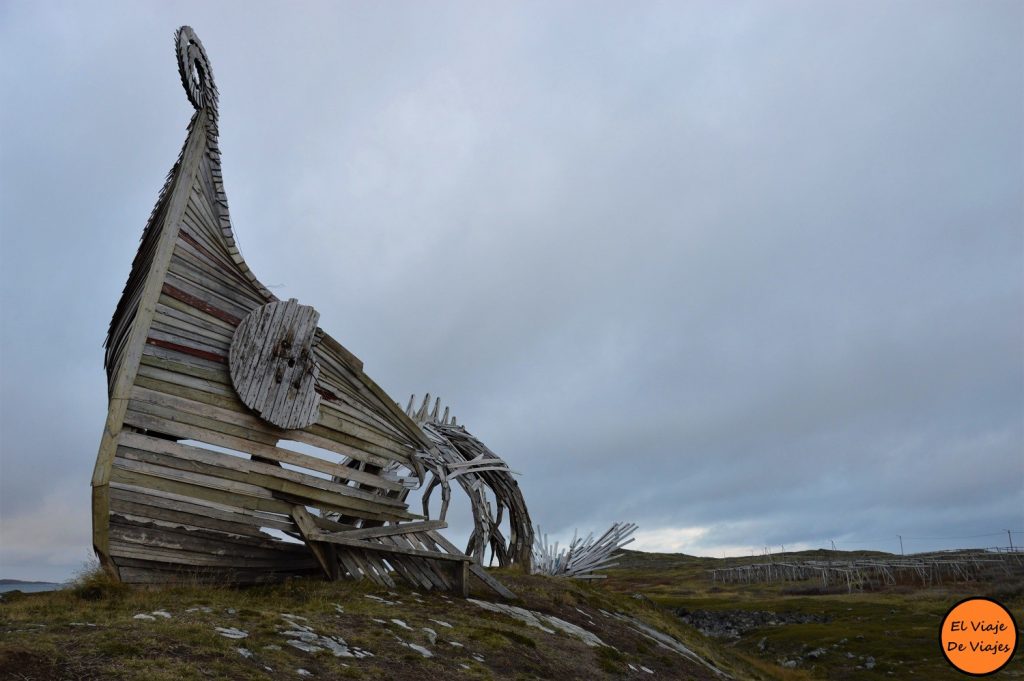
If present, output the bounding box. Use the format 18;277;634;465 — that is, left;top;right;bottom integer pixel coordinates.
92;27;534;597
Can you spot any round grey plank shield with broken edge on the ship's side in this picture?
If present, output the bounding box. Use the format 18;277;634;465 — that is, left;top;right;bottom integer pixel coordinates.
228;298;321;429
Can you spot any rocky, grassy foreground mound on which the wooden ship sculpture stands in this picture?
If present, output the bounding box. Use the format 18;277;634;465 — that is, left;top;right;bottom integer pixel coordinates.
0;561;753;681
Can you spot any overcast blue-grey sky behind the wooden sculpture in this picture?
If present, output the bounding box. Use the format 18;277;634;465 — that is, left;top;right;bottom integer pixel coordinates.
0;1;1024;579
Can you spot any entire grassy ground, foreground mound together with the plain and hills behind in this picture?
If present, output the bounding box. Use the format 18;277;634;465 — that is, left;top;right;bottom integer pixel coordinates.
0;552;1024;681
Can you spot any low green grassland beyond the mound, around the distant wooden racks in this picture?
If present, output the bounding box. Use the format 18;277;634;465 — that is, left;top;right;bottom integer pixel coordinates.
607;552;1024;680
